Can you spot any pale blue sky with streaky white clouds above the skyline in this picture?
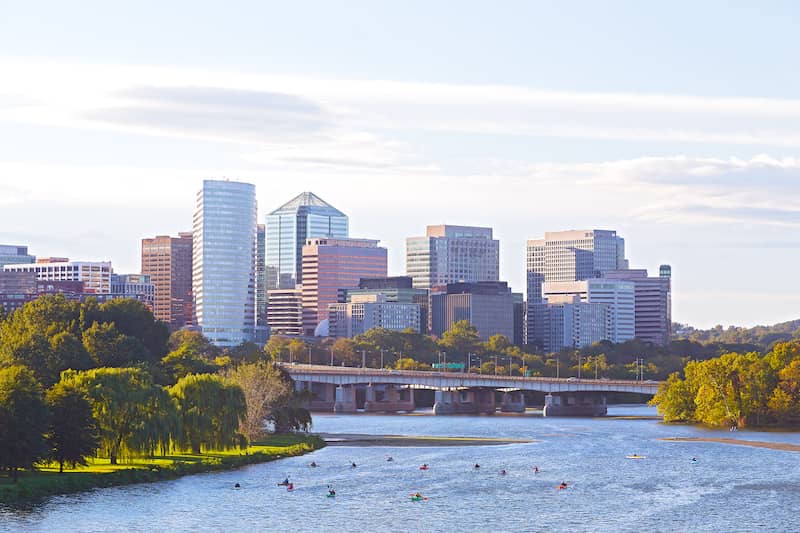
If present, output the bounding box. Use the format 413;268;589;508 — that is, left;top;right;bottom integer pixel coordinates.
0;0;800;327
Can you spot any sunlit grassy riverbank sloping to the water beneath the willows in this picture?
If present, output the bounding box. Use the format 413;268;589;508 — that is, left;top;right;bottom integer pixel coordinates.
0;435;325;504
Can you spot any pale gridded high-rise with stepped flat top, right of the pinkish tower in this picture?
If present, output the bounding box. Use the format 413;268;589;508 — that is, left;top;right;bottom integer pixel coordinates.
406;224;500;289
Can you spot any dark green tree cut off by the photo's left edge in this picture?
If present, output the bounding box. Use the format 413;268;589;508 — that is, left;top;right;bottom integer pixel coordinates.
0;366;48;483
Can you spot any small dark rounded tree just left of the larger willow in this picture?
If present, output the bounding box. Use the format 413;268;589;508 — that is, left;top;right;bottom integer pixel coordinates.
46;383;99;472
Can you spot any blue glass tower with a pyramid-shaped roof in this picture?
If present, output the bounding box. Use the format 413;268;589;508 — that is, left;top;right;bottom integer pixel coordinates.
264;192;349;289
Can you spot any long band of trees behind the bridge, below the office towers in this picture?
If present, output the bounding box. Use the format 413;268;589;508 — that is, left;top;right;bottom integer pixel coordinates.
265;321;756;380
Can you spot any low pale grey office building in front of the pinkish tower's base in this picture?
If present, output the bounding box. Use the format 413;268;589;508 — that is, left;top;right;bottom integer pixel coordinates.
328;293;420;338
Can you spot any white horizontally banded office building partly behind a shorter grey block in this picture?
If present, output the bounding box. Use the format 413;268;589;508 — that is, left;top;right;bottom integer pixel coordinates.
542;278;635;346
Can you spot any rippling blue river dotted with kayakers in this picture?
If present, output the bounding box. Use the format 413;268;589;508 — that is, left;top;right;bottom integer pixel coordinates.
0;406;800;532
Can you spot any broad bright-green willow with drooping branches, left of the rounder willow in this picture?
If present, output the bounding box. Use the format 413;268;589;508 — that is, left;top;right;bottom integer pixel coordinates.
61;368;166;464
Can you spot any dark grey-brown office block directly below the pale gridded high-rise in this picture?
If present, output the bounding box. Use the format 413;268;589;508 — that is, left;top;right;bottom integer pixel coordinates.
430;281;514;341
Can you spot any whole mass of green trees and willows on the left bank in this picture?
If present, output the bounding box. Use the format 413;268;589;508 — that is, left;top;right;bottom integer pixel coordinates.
0;295;311;481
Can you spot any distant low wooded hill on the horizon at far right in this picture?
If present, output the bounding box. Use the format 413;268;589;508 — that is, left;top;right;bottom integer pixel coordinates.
672;319;800;350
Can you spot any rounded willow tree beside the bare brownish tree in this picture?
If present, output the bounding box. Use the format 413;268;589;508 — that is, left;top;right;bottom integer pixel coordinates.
169;374;247;454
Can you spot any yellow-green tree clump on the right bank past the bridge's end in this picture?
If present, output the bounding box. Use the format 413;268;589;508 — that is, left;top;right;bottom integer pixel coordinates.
652;341;800;427
